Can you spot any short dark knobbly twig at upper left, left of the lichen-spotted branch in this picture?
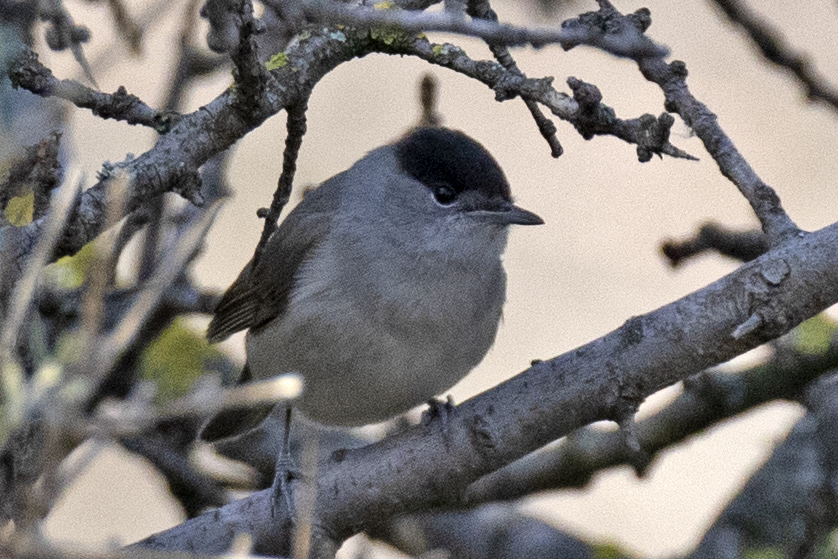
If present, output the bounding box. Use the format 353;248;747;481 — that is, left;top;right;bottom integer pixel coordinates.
9;47;178;134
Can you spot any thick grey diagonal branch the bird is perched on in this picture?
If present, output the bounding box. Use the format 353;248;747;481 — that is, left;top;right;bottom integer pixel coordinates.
138;224;838;553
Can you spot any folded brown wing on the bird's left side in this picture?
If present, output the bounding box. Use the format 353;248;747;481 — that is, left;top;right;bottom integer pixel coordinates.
207;184;341;343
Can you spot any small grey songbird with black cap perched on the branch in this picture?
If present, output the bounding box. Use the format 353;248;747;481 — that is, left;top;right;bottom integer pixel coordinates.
202;127;543;446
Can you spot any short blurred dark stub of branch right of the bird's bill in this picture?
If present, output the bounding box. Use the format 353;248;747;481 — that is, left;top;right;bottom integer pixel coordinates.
661;223;768;268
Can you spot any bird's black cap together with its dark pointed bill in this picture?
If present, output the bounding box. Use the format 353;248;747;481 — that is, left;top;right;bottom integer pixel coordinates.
395;127;544;225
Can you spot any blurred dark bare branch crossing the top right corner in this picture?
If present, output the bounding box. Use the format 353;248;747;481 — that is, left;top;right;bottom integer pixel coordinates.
712;0;838;114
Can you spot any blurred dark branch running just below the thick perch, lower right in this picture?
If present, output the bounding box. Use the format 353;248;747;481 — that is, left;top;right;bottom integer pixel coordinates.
466;339;838;504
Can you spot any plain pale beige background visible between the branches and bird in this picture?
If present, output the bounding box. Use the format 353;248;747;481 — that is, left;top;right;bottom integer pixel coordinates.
34;0;838;557
